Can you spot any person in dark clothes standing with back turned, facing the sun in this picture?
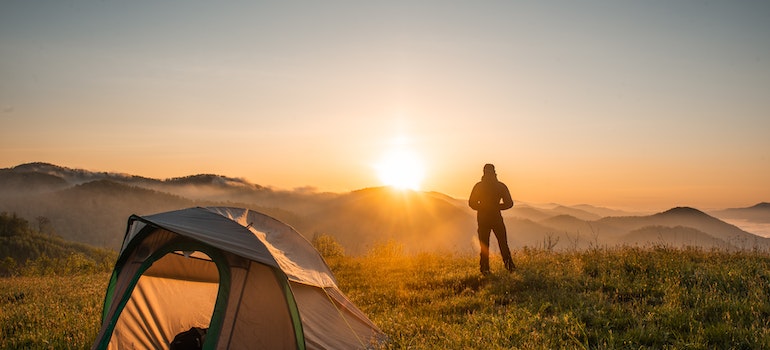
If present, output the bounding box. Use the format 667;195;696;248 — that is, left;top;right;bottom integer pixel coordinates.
468;164;515;275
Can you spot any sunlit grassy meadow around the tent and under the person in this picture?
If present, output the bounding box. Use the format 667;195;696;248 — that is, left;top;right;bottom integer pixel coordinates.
0;244;770;349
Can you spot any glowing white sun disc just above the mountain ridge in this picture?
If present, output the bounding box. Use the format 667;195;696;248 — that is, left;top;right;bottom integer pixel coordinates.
375;149;425;190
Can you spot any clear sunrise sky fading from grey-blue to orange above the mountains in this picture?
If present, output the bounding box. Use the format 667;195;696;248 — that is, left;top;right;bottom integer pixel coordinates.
0;0;770;210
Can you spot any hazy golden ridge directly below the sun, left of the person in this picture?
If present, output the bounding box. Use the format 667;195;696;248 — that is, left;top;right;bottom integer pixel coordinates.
306;187;475;254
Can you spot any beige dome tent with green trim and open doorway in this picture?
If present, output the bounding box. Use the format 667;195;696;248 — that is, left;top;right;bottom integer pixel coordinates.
92;207;383;349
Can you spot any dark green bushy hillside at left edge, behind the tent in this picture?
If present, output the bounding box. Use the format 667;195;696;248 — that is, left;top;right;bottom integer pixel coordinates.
0;213;117;276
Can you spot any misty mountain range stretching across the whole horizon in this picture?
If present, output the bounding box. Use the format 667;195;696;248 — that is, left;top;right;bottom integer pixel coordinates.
0;163;770;254
